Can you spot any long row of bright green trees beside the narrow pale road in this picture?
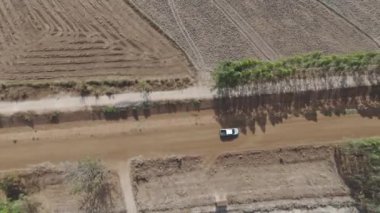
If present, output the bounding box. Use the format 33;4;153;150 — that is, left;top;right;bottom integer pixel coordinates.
213;52;380;88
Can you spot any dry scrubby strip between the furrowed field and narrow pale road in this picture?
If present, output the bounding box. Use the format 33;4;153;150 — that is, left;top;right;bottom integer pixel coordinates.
0;78;193;101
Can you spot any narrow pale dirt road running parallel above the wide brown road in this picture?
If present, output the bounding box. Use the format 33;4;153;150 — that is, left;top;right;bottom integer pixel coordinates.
0;75;380;115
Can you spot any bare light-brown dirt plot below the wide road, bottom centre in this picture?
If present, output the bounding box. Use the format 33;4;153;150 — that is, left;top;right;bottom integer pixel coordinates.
131;147;354;212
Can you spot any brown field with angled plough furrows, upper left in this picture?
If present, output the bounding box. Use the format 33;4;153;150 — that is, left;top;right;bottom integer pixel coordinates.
0;0;192;83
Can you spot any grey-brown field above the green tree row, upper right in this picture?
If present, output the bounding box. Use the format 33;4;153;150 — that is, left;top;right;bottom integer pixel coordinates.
130;0;380;70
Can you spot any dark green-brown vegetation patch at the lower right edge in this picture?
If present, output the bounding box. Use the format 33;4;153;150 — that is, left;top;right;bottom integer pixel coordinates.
338;138;380;212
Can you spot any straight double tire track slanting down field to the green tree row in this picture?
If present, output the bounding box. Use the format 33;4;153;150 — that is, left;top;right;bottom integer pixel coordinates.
212;0;279;59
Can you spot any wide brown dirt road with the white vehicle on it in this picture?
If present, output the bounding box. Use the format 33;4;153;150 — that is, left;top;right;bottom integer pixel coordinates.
0;111;380;169
